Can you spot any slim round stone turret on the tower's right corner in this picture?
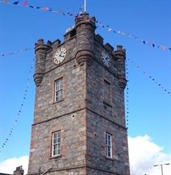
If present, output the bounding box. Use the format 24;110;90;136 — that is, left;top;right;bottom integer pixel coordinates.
113;45;127;90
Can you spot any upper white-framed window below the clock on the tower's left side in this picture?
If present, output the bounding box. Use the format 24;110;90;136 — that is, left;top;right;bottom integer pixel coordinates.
55;78;63;102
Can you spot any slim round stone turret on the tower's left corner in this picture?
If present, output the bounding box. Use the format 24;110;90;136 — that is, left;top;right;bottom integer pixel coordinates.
33;39;52;86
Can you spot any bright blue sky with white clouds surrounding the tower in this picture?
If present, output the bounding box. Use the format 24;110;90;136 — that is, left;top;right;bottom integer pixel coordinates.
0;0;171;175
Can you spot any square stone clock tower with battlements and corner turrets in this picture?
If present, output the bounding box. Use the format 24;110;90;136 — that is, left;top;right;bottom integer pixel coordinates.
28;13;130;175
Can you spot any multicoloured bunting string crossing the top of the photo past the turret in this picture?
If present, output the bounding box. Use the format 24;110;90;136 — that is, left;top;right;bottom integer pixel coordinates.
0;0;171;51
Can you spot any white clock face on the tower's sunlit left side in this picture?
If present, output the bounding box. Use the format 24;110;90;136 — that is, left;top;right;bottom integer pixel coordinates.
53;47;66;64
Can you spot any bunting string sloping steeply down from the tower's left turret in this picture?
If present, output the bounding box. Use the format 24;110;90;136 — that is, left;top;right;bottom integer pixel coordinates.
0;59;34;153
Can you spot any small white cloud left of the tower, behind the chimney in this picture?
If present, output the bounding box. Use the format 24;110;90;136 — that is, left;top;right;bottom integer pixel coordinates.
0;156;28;174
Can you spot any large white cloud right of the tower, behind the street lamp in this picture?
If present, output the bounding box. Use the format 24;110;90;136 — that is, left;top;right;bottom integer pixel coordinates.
128;135;171;175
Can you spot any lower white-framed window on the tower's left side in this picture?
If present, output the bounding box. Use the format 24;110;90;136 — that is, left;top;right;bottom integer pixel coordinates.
52;131;61;156
